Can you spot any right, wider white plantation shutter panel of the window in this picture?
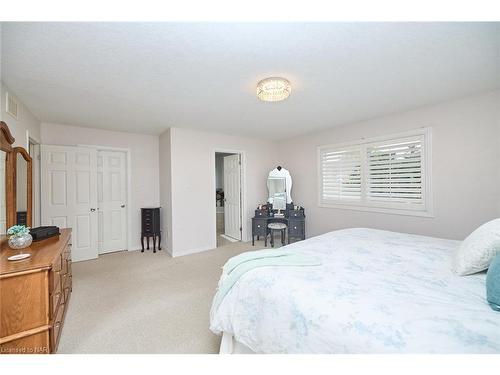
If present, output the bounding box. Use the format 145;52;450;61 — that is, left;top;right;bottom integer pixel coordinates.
366;136;424;206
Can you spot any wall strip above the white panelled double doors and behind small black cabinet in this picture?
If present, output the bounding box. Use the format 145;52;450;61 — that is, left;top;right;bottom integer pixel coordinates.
41;123;160;250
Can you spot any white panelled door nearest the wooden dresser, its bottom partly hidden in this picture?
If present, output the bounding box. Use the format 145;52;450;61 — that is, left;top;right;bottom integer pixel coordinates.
40;145;98;261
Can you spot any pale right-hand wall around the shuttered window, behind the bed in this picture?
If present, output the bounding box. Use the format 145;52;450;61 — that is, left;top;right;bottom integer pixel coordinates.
279;91;500;239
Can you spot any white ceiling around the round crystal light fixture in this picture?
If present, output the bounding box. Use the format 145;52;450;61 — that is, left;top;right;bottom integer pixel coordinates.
2;23;500;139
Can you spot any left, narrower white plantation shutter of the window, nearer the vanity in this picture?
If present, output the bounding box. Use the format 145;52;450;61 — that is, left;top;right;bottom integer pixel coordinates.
319;147;361;203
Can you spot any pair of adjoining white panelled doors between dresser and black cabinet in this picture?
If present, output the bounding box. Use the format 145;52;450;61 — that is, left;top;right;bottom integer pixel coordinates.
41;145;127;261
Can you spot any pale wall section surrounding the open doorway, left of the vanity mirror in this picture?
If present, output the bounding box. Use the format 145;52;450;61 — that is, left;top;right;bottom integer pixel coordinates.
160;128;276;256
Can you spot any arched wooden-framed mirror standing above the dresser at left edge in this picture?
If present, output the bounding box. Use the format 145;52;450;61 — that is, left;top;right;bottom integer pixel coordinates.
0;121;32;235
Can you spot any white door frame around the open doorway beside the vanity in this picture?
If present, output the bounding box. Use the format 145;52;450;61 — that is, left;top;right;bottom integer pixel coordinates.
209;147;248;249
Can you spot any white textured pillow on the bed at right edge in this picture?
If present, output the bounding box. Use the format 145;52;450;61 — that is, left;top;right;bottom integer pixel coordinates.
453;219;500;276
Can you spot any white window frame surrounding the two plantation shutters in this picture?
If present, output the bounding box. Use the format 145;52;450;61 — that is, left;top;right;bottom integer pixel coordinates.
316;127;434;217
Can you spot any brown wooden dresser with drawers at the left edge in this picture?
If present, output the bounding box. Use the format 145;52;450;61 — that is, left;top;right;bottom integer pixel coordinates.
0;229;72;354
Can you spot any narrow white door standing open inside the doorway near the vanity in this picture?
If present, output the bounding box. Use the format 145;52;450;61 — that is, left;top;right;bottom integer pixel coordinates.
224;155;241;240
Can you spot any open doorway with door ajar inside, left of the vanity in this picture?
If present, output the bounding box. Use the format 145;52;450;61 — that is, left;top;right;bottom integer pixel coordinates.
215;152;242;247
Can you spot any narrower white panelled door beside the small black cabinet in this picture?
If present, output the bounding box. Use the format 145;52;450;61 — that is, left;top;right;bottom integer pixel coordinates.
97;151;127;254
